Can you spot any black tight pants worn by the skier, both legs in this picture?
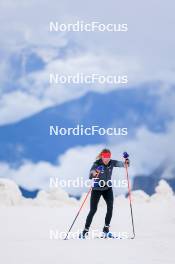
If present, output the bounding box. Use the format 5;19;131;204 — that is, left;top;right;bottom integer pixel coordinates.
85;188;114;229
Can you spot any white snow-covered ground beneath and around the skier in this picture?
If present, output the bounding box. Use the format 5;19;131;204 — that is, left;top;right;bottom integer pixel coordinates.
0;179;175;264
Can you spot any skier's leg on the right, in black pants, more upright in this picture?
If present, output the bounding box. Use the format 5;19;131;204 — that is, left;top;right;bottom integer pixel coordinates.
102;188;114;227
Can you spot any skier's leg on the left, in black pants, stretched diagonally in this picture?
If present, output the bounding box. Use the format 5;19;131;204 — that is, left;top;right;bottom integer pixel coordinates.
85;190;102;230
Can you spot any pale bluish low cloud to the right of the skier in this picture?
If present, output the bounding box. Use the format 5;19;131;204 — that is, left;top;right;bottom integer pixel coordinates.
109;122;175;177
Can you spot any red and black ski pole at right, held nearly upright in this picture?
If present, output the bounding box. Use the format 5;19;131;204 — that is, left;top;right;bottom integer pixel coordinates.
123;152;135;239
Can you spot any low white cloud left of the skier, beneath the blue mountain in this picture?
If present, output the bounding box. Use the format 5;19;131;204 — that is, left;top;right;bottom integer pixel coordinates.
0;146;102;194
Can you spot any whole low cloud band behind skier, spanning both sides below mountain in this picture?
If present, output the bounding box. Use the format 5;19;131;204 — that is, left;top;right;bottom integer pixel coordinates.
0;120;175;195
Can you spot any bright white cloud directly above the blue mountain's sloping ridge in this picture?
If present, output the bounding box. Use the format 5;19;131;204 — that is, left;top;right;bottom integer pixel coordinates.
0;48;144;125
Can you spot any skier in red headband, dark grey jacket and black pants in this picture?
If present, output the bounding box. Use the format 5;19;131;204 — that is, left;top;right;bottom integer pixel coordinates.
80;149;130;238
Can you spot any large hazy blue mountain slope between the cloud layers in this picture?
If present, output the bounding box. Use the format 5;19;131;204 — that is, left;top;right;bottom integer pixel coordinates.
0;84;171;164
